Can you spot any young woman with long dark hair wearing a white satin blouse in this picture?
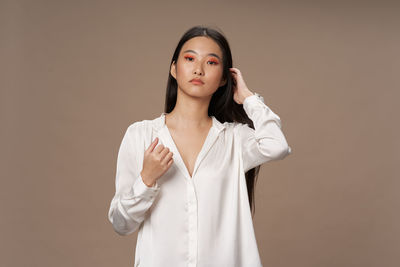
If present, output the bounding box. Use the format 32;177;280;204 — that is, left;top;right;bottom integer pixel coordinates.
108;26;291;267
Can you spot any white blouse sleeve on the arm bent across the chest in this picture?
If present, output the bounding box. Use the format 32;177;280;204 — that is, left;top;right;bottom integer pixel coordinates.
108;123;160;235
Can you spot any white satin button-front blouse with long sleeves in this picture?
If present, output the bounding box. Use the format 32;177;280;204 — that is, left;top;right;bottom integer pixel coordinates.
108;95;291;267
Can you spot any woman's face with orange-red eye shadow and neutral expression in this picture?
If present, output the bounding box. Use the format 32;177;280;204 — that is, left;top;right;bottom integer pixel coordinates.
171;36;226;98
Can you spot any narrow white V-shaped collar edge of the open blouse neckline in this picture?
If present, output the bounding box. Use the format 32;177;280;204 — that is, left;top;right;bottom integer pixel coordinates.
161;112;215;180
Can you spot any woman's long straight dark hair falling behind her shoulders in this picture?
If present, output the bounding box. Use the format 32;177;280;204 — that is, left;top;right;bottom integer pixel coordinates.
164;25;260;218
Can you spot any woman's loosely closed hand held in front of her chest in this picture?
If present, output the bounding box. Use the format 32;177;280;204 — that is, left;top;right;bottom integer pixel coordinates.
140;137;174;187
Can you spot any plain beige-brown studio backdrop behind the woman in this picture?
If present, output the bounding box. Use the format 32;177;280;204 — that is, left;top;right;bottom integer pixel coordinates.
0;1;400;267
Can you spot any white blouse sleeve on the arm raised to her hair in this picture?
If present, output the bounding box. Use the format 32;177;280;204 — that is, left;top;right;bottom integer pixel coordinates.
236;95;292;172
